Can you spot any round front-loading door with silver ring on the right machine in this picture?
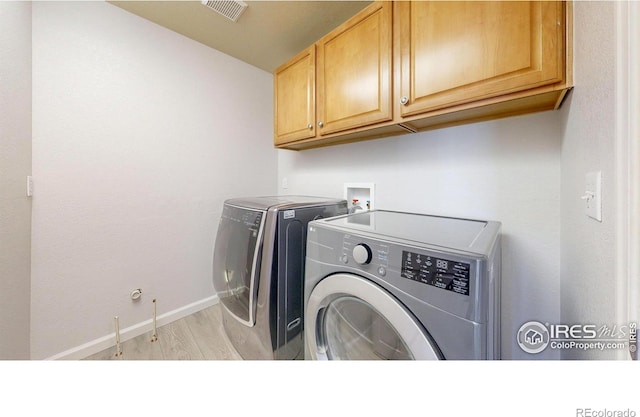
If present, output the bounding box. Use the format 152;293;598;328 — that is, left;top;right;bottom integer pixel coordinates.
304;274;441;360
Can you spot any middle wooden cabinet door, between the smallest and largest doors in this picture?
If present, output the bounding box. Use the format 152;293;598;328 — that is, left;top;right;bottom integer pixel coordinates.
317;1;392;135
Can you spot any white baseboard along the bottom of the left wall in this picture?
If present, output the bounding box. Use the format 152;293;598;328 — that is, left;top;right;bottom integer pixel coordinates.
45;295;220;360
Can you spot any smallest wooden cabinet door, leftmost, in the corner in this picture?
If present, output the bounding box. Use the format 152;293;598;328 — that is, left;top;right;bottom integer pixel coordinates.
273;45;316;145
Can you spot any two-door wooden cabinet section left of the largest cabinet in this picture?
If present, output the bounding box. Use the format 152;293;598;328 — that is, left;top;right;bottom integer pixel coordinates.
274;1;407;149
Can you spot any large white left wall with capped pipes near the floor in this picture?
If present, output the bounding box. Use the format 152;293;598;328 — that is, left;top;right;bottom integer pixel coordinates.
31;2;277;359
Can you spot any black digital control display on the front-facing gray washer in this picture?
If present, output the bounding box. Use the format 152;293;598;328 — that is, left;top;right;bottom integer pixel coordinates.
400;251;471;295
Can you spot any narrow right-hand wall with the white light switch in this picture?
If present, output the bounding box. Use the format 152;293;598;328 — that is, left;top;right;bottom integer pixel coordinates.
561;1;625;359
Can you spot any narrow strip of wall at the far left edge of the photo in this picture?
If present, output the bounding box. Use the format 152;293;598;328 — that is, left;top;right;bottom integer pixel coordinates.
0;2;31;359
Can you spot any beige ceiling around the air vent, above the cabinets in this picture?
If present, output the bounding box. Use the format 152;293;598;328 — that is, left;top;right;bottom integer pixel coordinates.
109;0;371;72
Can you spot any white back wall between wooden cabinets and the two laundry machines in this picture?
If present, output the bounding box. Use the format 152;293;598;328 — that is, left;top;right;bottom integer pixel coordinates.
278;112;562;359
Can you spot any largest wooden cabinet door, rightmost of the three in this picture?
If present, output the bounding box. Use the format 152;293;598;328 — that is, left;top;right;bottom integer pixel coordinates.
396;1;564;116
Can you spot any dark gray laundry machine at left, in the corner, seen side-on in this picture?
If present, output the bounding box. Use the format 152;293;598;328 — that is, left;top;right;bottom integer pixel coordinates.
213;196;347;359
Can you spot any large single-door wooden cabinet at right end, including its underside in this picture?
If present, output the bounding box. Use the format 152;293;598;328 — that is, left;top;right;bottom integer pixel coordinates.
394;1;572;131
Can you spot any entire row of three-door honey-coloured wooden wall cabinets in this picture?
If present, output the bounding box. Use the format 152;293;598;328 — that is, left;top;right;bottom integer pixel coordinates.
274;1;573;149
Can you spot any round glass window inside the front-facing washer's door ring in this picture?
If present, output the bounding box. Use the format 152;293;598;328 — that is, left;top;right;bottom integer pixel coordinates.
323;297;414;360
